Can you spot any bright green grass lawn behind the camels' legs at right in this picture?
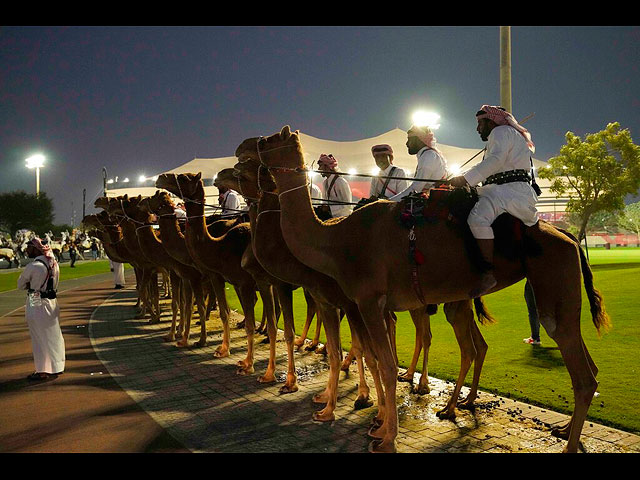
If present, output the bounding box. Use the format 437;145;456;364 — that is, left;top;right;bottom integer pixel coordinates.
227;248;640;432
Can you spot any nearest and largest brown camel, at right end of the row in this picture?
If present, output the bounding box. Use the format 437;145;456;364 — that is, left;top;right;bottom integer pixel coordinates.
250;126;610;452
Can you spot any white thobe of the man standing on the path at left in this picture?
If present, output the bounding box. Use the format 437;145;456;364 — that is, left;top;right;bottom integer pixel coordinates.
18;255;65;373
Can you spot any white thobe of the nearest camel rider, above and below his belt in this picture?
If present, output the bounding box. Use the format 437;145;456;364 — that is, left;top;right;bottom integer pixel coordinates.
464;125;538;239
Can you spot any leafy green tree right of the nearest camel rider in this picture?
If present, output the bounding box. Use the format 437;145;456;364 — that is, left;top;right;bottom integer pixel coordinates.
538;122;640;241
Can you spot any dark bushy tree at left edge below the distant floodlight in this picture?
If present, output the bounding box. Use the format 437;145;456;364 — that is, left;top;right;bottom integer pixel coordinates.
0;190;54;235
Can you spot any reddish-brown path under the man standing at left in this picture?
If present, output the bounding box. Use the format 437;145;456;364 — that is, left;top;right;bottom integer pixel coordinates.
0;271;189;453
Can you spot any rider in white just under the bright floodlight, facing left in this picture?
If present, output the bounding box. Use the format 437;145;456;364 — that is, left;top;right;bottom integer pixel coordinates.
389;125;449;202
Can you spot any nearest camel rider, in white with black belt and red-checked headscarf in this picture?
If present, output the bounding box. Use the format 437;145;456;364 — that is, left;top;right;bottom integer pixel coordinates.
451;105;538;298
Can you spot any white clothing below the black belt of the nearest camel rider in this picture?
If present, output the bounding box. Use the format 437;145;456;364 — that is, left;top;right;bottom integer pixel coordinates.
467;182;538;239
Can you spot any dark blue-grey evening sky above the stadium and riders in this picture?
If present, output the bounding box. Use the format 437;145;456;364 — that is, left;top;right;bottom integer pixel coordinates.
0;26;640;227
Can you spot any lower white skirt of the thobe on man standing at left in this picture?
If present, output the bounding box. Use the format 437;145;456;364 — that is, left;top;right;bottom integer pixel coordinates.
25;298;65;373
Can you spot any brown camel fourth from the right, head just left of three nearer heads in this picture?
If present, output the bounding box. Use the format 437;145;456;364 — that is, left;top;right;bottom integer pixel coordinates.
156;173;276;382
